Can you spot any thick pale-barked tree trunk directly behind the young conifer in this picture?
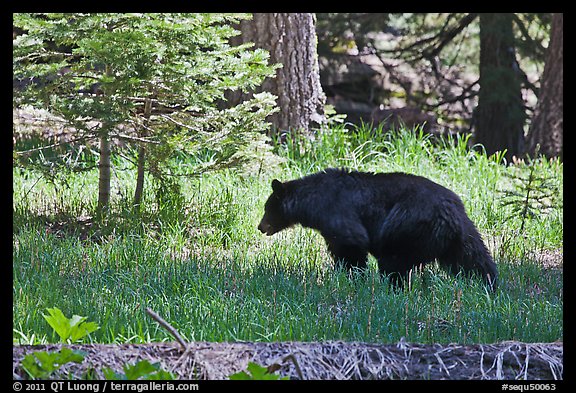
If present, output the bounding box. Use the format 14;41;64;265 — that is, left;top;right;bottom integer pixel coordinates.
229;13;326;137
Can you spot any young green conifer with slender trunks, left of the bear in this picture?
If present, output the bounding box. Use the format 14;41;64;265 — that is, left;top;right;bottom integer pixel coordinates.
13;13;276;213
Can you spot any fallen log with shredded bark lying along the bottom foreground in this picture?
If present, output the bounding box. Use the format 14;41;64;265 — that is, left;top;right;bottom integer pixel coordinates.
12;340;564;380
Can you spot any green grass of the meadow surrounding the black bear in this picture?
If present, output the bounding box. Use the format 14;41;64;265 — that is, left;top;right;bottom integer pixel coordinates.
13;127;563;343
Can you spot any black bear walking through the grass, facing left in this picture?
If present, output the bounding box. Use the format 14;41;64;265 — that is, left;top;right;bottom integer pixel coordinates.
258;168;497;289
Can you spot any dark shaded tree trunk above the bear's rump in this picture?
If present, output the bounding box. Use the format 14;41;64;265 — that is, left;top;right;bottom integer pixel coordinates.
474;13;526;160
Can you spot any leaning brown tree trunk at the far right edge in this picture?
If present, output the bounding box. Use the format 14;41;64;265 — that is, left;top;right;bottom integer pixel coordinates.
527;14;564;158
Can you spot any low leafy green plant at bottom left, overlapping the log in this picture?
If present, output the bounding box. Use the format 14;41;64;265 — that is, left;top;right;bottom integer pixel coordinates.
22;348;86;379
